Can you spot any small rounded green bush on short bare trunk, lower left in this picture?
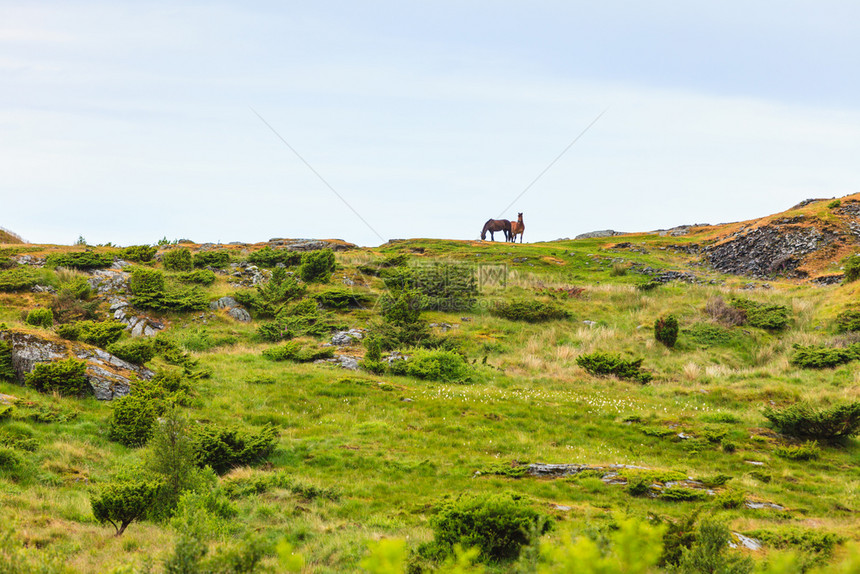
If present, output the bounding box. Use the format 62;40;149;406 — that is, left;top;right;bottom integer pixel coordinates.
90;478;162;536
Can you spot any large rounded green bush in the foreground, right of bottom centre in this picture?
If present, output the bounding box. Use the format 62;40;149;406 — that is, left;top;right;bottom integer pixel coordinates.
422;493;551;563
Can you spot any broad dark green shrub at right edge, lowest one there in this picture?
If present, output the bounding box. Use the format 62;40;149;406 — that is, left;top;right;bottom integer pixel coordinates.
764;401;860;441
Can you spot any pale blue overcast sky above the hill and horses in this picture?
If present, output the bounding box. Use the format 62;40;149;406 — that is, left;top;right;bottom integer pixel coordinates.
0;0;860;245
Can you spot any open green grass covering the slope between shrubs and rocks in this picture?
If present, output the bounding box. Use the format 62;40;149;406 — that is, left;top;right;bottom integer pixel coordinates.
0;236;860;572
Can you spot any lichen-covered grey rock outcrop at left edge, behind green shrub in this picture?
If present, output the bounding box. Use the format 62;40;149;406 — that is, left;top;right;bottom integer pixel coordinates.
0;330;155;401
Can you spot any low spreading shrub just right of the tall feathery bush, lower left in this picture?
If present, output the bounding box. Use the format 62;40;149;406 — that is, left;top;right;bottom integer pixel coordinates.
192;424;278;474
